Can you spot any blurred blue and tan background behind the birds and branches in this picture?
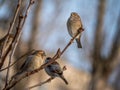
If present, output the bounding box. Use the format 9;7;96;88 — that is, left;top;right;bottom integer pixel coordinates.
0;0;120;90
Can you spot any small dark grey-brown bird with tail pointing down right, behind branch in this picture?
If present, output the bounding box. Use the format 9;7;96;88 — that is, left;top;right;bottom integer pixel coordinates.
45;57;68;84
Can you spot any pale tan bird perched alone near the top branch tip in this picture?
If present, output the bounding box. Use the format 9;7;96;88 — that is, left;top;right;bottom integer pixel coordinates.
67;12;83;48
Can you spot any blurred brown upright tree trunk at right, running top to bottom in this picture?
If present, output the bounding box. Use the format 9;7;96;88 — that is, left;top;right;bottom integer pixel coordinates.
90;0;106;90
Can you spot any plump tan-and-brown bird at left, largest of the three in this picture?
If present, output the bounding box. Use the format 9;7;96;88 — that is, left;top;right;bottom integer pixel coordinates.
12;50;46;78
